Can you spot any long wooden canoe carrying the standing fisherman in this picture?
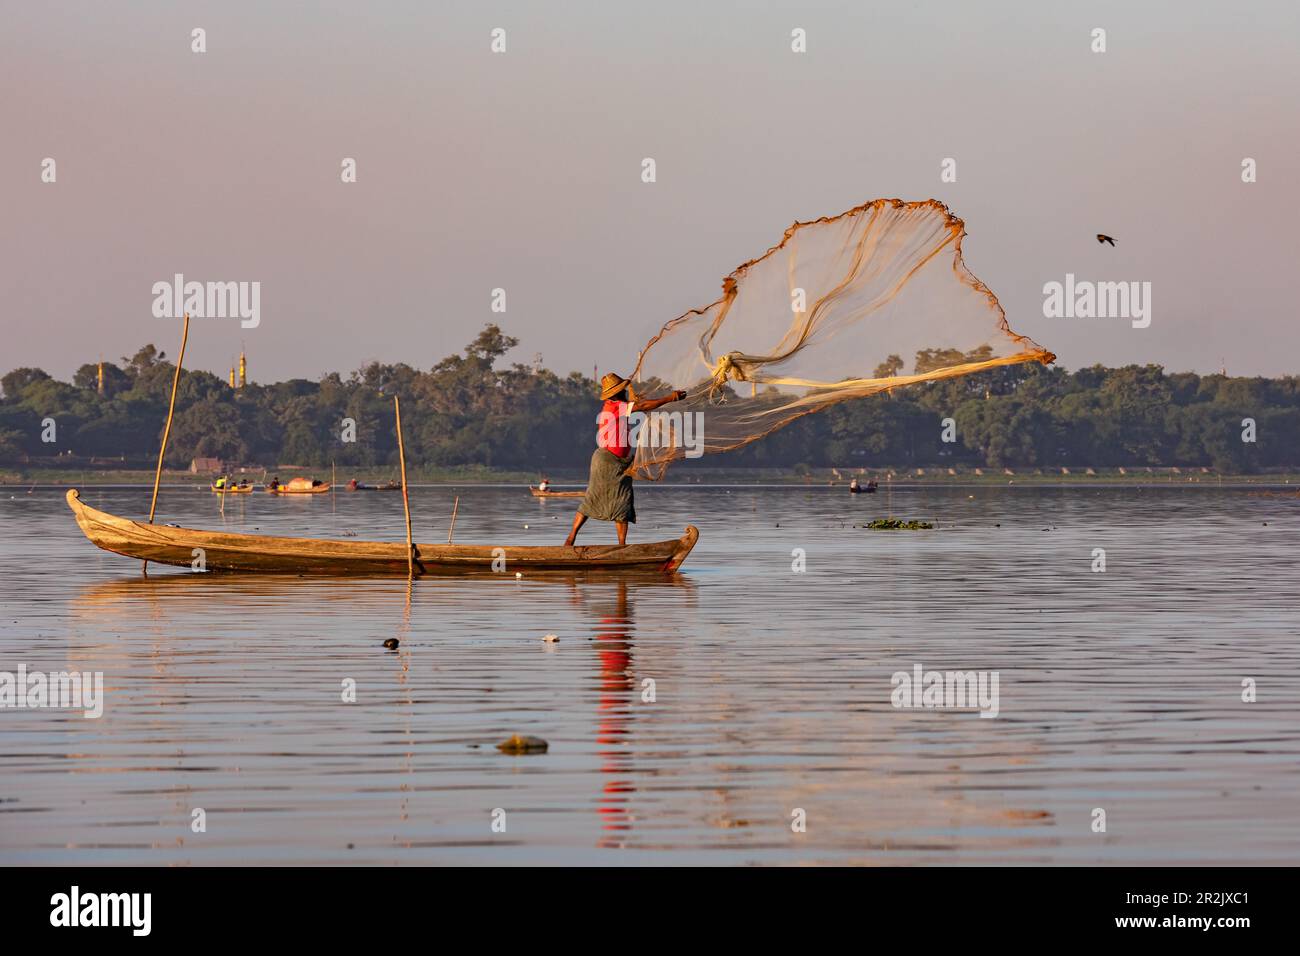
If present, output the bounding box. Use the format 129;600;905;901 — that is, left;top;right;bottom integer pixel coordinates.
68;488;699;575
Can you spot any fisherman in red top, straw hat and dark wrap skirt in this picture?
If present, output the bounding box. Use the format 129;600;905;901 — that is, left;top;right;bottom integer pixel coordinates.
564;372;686;548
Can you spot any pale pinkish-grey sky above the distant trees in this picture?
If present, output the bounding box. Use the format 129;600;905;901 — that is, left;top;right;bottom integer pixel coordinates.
0;0;1300;381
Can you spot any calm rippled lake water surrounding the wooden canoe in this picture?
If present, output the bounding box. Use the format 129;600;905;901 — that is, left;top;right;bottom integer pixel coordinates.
0;485;1300;865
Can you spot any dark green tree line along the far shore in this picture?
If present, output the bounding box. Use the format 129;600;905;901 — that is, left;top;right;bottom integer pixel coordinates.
0;325;1300;473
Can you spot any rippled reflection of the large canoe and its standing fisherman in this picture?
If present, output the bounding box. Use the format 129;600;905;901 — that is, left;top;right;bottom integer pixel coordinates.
69;571;698;848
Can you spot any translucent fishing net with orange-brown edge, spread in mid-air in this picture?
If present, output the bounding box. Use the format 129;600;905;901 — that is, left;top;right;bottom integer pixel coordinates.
629;199;1056;479
